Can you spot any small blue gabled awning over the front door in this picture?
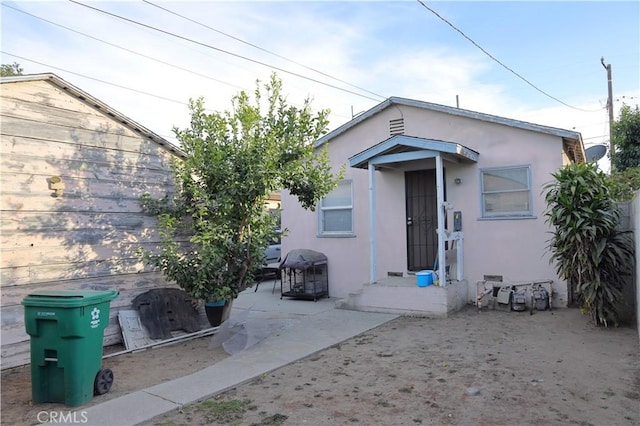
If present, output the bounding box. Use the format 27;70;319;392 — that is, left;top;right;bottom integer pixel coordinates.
349;135;480;169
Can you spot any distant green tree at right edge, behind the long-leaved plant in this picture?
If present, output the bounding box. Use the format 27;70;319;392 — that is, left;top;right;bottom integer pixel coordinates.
611;105;640;171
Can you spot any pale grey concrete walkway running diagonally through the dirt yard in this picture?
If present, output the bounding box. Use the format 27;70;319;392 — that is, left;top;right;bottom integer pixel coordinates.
58;280;397;426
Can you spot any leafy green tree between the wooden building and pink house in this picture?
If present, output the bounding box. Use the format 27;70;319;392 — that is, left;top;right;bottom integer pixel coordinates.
140;75;340;301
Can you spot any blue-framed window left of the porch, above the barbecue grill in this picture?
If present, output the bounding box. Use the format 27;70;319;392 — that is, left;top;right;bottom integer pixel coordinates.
319;180;353;236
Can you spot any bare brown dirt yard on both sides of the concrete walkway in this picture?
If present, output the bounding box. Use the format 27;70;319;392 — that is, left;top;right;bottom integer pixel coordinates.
2;308;640;426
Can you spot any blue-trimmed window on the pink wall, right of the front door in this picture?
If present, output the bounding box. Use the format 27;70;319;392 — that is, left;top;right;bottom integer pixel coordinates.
480;166;533;218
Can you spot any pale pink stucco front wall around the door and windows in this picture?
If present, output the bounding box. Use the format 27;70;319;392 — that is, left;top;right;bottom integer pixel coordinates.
282;105;566;306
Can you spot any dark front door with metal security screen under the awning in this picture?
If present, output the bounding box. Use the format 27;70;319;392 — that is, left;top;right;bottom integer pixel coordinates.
404;170;438;271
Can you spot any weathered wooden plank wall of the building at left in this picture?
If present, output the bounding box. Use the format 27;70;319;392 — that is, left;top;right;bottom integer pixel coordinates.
0;76;181;369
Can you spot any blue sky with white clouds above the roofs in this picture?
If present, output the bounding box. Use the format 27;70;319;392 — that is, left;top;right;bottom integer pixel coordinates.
0;0;640;169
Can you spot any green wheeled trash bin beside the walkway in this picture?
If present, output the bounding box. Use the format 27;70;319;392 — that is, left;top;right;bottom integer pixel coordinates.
22;290;118;407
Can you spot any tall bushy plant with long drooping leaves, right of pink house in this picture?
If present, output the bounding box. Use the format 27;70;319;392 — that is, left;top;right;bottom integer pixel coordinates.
545;163;633;327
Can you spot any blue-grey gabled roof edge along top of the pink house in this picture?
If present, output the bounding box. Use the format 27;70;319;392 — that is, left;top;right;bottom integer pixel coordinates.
316;96;585;162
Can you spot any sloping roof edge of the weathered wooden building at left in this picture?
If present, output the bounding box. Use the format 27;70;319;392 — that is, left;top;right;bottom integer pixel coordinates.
0;73;184;157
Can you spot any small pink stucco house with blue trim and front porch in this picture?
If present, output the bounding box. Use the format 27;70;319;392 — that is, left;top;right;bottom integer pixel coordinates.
282;97;585;316
